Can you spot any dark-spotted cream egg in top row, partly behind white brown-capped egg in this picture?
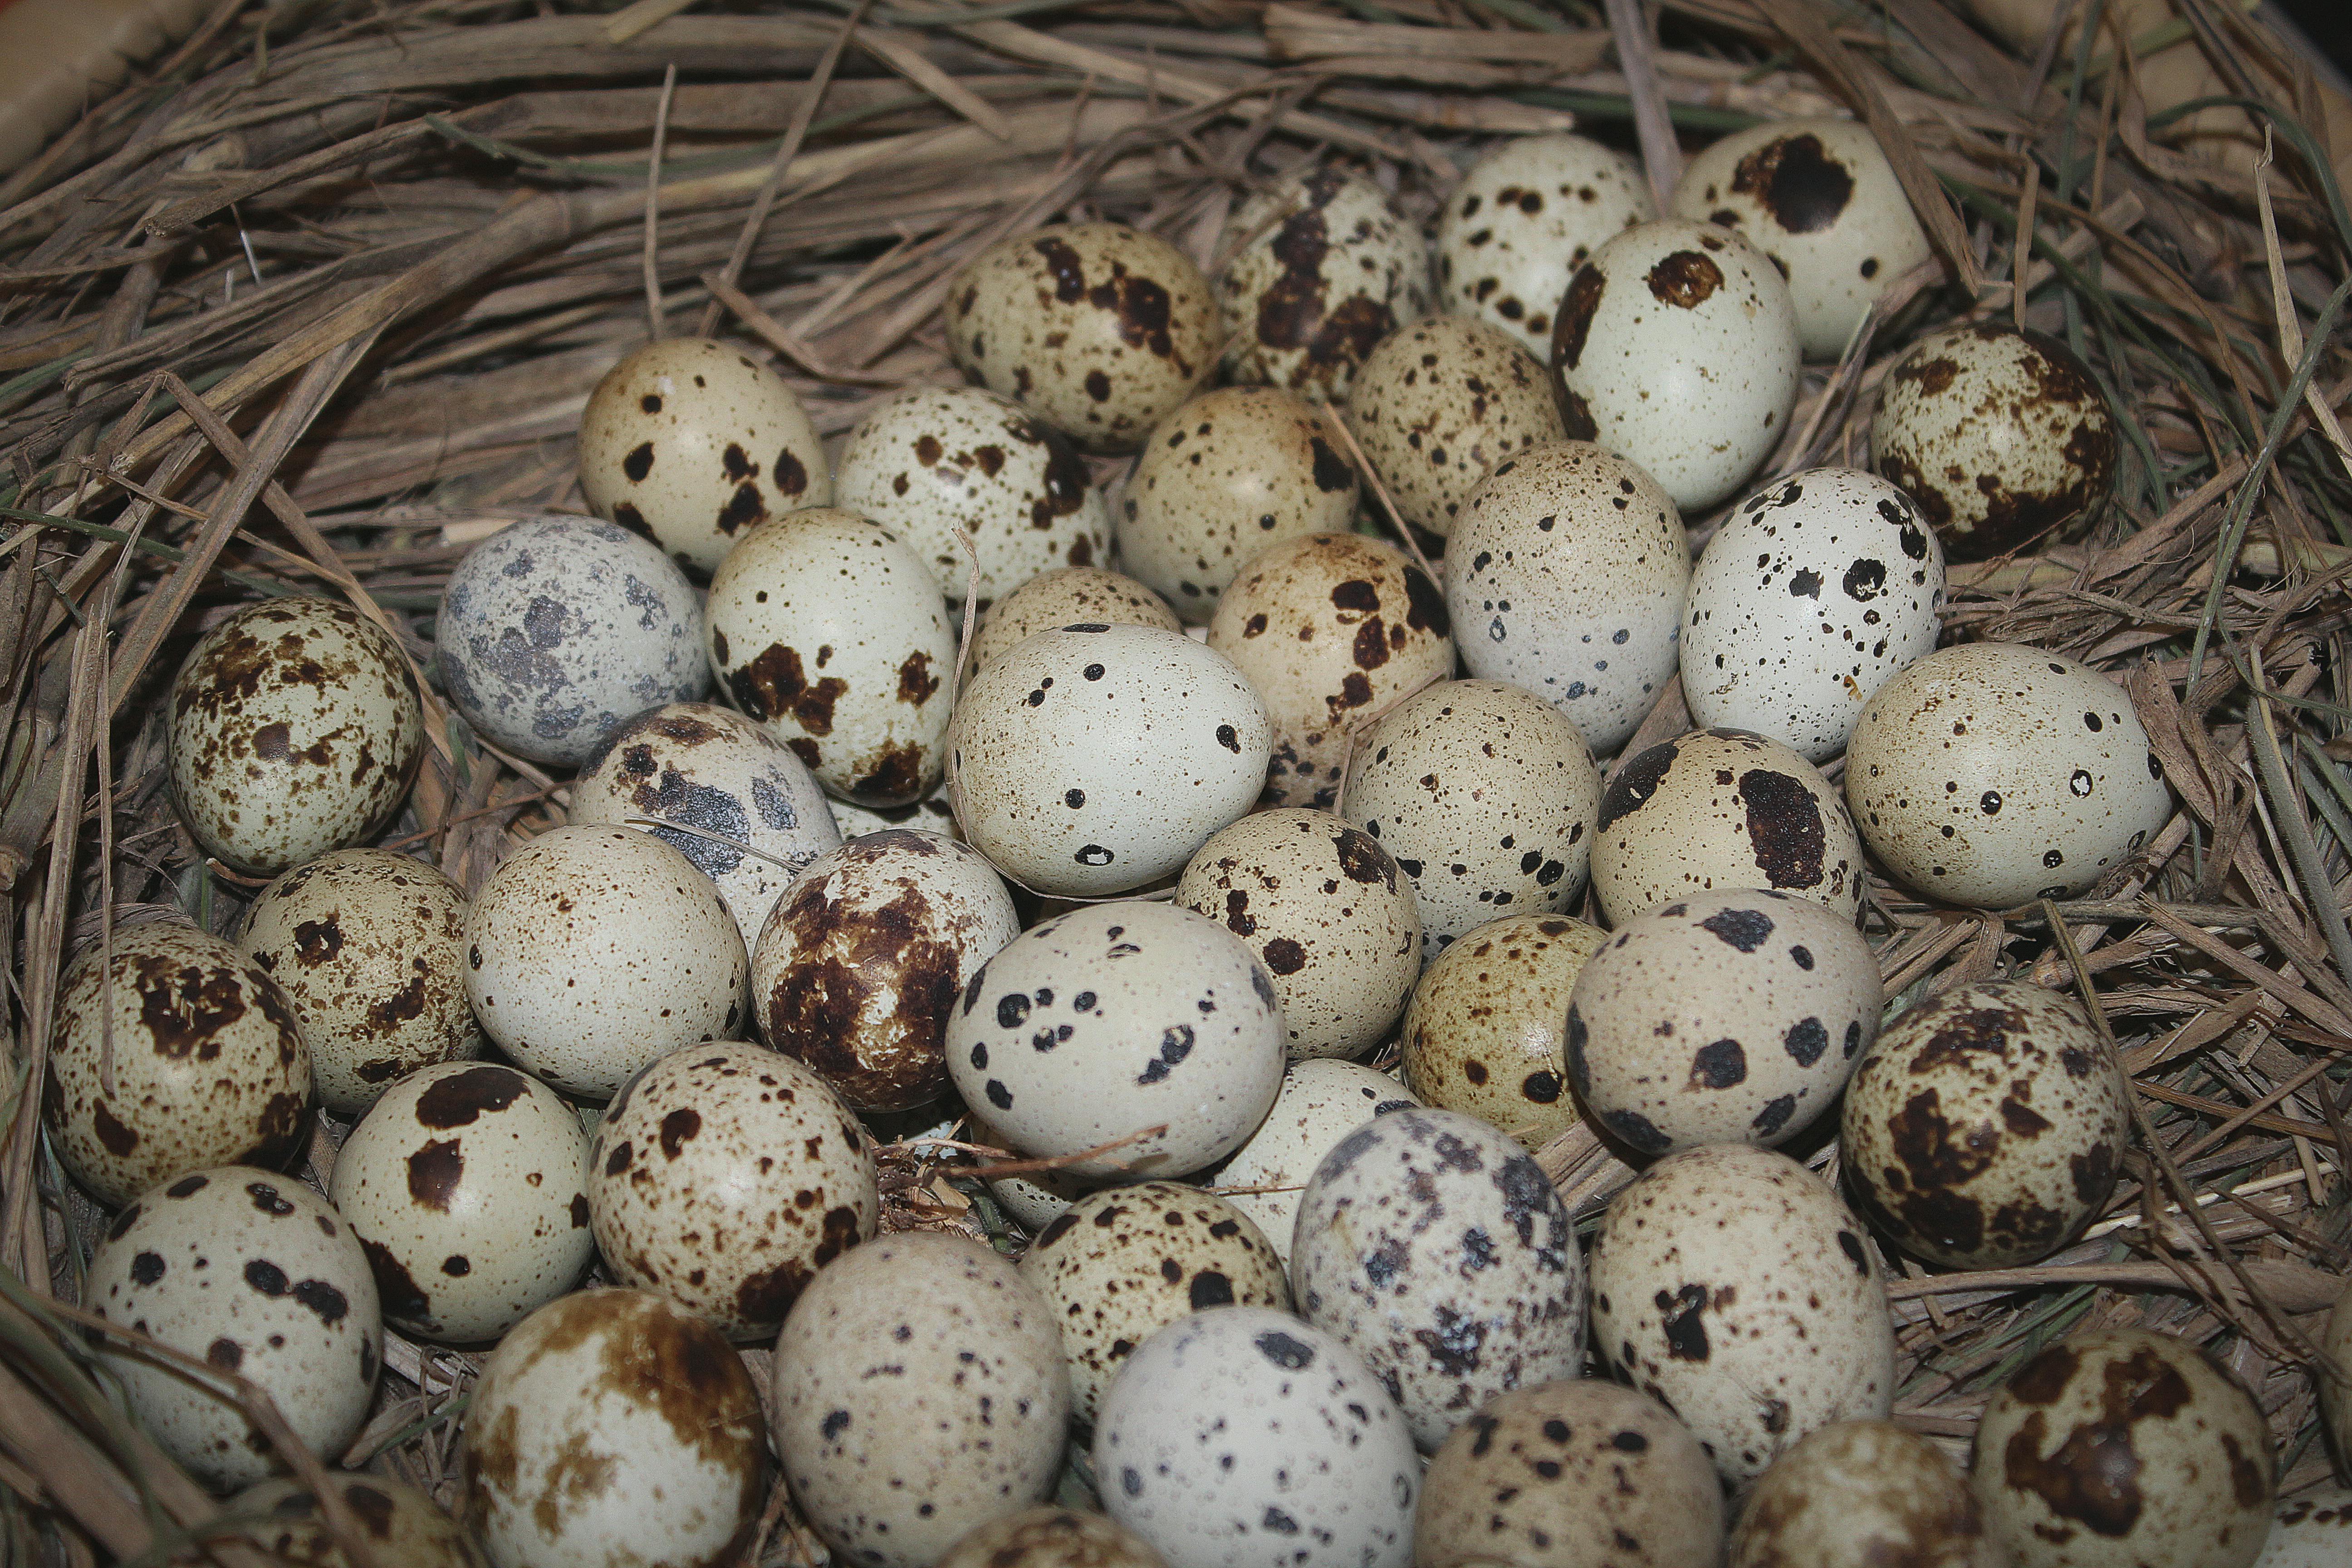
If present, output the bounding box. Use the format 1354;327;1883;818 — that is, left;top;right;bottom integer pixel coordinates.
1437;132;1658;360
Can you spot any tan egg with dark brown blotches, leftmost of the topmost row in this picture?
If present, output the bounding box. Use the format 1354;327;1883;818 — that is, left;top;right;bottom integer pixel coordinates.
943;223;1223;451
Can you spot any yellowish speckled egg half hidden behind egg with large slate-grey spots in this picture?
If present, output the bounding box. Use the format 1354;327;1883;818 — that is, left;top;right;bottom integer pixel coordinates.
1399;915;1609;1150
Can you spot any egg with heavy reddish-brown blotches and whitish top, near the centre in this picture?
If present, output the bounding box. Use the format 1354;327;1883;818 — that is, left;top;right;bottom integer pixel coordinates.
750;828;1021;1110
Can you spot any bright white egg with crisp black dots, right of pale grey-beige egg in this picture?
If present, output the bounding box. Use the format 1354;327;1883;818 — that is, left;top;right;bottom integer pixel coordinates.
1682;468;1943;764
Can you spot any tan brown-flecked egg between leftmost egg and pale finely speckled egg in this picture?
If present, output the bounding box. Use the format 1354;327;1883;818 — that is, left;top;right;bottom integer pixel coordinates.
238;848;482;1117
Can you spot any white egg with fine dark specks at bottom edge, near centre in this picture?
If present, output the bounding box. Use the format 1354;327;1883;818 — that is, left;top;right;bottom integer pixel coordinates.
1094;1307;1418;1568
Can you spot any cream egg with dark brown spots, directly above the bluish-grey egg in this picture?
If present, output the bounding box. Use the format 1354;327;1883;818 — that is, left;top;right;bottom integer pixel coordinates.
578;338;833;573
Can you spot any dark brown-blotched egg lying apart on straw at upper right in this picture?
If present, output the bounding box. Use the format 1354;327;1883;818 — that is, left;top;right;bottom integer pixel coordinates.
1870;322;2117;562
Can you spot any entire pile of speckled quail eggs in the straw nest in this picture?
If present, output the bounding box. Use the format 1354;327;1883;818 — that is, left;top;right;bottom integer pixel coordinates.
59;104;2352;1568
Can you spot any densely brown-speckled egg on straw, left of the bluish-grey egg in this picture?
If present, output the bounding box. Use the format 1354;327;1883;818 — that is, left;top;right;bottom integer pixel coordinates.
172;599;426;877
